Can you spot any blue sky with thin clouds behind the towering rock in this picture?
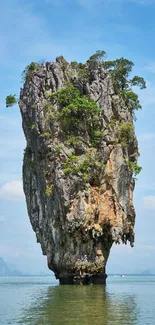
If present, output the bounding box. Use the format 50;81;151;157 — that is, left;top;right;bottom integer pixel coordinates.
0;0;155;273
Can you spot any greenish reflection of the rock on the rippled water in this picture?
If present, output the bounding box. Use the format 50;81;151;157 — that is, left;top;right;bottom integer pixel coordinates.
18;286;138;325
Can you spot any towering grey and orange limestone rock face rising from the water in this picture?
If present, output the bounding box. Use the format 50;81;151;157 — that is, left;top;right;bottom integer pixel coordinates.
19;57;138;284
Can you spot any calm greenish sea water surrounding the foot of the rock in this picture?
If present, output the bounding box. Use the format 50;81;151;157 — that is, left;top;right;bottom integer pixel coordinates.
0;276;155;325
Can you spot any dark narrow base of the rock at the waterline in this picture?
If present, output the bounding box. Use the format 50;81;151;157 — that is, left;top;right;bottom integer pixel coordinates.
58;273;107;285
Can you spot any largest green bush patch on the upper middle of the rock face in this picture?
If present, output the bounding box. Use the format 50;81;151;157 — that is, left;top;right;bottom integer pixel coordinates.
50;84;103;146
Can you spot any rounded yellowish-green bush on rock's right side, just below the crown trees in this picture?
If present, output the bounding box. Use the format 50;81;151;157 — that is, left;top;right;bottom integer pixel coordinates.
116;123;134;145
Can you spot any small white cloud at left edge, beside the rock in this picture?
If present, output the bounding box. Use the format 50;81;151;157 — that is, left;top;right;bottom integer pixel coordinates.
0;180;24;201
